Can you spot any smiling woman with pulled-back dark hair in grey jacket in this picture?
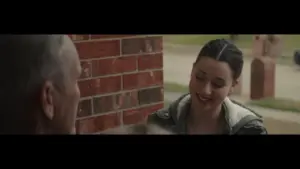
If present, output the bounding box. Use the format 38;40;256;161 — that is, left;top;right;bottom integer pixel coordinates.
148;39;267;135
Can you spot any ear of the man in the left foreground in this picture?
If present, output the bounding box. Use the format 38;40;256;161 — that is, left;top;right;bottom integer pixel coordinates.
41;81;54;120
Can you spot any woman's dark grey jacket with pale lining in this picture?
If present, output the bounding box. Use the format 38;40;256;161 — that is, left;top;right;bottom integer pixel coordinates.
147;94;267;135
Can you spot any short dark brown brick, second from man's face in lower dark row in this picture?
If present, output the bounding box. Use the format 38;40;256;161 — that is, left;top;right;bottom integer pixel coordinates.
93;95;115;114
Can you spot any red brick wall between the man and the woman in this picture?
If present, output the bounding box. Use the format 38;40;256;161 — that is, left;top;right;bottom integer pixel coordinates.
70;35;163;134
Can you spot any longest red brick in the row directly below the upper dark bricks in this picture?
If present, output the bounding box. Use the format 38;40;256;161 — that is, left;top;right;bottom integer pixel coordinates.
92;56;137;77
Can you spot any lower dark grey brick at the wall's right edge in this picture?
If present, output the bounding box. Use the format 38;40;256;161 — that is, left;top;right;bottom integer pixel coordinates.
138;87;163;105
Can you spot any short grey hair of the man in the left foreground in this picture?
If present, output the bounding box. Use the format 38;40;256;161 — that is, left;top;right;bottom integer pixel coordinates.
0;35;64;134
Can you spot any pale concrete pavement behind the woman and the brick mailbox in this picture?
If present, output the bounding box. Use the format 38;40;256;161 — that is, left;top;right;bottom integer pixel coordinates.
164;46;300;100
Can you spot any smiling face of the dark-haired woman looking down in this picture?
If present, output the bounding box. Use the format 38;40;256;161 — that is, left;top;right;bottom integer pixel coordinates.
189;56;237;111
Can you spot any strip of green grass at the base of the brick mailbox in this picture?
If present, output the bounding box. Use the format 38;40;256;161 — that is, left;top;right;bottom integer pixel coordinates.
247;98;300;113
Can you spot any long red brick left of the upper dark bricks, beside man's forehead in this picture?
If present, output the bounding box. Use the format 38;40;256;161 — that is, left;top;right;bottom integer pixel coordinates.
75;40;120;59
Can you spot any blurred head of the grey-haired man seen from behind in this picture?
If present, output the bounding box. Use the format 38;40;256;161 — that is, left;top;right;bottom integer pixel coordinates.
0;35;81;134
